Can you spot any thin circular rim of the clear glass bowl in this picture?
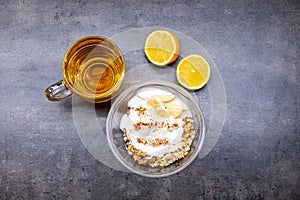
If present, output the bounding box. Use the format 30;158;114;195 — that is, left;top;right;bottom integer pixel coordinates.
106;80;206;178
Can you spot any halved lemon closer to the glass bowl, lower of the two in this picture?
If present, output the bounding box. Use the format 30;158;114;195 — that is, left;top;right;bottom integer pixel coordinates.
176;54;210;90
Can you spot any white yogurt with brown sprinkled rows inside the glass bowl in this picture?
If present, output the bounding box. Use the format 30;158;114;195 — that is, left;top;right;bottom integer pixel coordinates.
120;88;191;157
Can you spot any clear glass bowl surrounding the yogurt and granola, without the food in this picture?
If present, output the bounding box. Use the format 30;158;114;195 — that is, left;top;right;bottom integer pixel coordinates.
106;81;205;177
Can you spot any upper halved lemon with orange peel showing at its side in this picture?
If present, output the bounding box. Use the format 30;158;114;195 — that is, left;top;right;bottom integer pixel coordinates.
144;30;180;66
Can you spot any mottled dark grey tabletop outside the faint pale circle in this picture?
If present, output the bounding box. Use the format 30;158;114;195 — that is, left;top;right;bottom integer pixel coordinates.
0;0;300;199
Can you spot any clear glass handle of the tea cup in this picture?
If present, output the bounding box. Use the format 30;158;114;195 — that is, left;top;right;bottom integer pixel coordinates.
45;80;73;101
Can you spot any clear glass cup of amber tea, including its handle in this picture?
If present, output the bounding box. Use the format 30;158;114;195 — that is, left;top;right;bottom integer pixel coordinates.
45;36;126;103
